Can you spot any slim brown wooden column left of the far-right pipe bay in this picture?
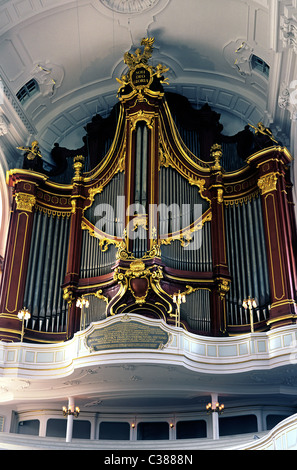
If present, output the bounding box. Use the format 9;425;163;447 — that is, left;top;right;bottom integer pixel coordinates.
209;144;230;335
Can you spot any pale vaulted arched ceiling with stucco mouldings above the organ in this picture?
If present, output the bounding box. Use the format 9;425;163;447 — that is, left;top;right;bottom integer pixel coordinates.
0;0;297;166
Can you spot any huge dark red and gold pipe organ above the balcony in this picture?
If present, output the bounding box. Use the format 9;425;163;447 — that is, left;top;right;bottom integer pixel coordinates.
0;38;296;342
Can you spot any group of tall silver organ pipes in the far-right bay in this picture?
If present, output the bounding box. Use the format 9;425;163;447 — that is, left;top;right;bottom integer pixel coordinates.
225;197;270;325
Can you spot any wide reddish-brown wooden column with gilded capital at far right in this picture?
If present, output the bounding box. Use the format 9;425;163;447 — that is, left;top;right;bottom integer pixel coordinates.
254;148;297;328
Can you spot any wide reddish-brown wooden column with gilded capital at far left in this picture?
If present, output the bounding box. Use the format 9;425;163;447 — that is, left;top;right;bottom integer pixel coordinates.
0;170;46;341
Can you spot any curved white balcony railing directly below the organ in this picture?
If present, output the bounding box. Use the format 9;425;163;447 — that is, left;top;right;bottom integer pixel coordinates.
0;314;297;378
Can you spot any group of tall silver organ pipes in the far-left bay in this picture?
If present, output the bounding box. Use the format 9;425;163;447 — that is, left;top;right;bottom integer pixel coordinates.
24;212;69;331
